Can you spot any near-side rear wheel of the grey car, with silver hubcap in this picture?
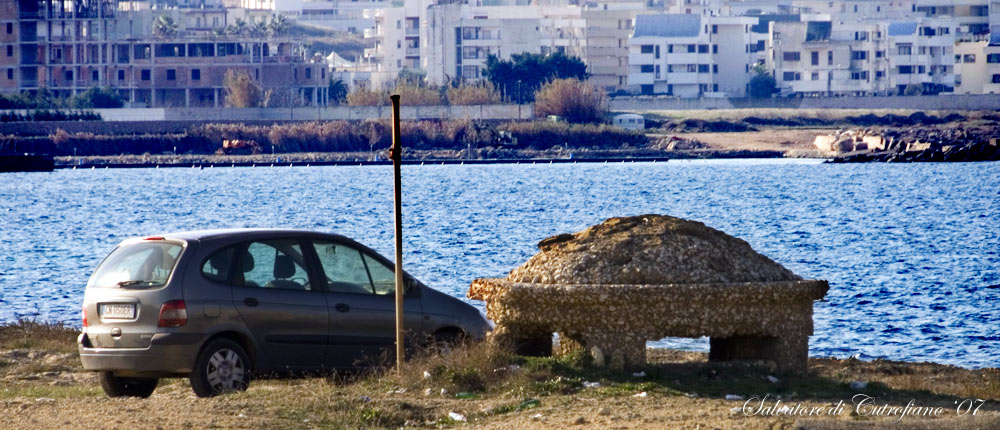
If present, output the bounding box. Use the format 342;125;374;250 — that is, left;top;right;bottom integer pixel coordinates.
189;339;250;397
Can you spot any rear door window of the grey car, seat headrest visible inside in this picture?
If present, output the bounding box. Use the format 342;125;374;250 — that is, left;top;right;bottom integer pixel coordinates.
234;239;312;291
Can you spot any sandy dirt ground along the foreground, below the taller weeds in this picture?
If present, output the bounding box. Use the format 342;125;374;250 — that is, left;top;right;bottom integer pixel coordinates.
0;349;1000;430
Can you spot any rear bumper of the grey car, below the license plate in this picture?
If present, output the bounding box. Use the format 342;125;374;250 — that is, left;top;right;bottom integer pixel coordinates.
77;333;204;375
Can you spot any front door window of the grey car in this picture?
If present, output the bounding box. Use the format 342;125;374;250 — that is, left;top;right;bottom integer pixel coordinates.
313;240;372;294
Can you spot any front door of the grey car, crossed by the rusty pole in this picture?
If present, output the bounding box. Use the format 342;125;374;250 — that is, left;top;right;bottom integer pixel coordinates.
313;240;423;367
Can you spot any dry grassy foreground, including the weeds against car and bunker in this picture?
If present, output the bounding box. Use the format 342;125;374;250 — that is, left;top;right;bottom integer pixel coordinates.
0;322;1000;430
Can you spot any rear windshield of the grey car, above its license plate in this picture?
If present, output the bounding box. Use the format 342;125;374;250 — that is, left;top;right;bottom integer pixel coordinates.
87;241;183;288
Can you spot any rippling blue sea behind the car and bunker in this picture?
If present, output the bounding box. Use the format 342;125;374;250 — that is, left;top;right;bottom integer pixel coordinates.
0;160;1000;368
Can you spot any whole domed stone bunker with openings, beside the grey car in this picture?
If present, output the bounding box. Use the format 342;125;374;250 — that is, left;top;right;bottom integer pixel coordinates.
468;215;828;371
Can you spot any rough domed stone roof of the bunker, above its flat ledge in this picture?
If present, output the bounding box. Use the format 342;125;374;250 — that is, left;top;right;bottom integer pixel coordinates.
507;215;802;285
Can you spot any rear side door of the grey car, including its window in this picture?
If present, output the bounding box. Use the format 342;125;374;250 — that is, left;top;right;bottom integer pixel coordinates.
232;239;330;370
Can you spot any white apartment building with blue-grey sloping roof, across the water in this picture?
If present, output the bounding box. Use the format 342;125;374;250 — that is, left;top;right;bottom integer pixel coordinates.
628;14;757;97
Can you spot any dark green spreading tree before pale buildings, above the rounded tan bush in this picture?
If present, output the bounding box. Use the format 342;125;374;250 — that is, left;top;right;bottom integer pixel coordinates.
484;53;587;103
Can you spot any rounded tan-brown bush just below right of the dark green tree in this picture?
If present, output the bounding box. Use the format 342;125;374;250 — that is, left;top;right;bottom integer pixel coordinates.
535;78;608;123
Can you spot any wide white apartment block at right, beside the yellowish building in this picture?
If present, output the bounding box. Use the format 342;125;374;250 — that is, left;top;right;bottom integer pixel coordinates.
767;15;955;97
